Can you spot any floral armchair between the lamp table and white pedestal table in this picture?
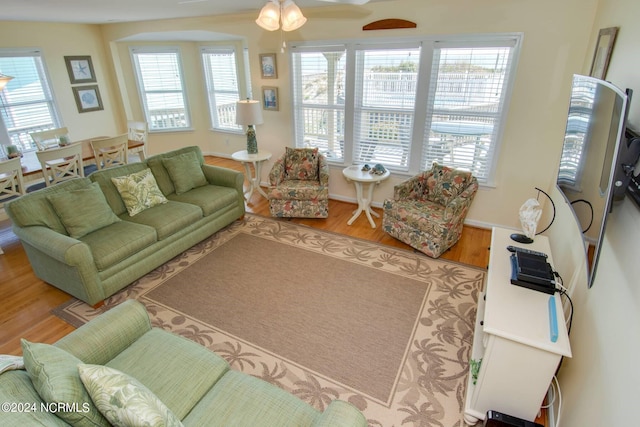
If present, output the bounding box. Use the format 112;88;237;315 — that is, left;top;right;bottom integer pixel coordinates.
268;147;329;218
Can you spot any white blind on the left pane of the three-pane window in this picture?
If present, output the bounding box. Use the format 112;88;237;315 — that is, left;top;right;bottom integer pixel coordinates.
291;47;346;161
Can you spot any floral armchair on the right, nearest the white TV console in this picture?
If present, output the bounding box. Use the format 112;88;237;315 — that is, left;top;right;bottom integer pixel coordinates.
382;163;478;258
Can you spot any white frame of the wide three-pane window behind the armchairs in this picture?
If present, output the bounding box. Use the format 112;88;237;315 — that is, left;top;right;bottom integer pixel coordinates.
289;33;523;186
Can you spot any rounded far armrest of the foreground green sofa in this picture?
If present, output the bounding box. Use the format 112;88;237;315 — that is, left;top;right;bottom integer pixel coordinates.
55;299;151;365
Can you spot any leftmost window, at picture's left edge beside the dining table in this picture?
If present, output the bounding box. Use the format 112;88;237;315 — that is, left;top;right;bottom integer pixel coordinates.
0;50;61;151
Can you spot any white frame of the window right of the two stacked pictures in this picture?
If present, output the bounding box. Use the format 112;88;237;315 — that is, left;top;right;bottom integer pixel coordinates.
129;46;192;133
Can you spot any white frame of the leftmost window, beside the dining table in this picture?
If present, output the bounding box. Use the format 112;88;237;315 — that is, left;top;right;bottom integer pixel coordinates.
0;49;63;151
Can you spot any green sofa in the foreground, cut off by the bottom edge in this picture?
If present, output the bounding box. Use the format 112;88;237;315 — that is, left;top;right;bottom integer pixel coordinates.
0;300;367;427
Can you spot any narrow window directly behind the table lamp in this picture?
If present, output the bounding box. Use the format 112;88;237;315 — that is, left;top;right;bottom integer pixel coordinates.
201;47;242;131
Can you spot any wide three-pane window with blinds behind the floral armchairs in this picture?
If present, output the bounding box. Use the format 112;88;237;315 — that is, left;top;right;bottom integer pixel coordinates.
291;35;520;184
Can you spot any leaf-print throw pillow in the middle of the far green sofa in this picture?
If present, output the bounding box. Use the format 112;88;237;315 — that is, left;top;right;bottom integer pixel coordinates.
111;169;167;216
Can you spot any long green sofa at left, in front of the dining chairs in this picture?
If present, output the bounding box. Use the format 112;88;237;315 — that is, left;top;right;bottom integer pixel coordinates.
5;147;245;305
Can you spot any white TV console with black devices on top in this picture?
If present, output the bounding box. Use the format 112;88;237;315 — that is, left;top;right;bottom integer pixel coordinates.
464;227;571;425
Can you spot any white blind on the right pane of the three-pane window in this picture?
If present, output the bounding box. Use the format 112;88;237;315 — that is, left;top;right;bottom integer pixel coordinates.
422;43;513;182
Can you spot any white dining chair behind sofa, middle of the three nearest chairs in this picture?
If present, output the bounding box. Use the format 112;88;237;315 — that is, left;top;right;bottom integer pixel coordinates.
36;142;84;187
